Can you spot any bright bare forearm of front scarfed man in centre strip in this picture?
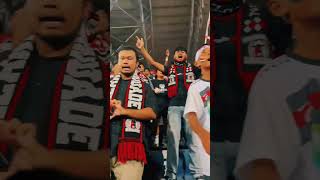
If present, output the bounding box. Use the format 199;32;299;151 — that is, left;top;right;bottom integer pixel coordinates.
123;108;157;120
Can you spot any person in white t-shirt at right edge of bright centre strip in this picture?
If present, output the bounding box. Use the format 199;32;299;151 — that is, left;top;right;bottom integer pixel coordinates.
184;45;210;179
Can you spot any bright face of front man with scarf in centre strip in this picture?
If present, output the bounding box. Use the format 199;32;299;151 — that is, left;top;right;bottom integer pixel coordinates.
118;50;137;76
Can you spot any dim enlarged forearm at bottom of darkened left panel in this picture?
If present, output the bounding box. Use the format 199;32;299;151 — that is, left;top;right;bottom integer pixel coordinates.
46;150;110;179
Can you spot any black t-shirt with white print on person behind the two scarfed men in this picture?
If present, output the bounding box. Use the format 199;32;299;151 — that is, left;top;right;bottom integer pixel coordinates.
152;79;168;111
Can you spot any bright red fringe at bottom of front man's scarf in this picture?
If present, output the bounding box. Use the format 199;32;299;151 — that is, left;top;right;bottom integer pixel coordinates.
118;141;147;164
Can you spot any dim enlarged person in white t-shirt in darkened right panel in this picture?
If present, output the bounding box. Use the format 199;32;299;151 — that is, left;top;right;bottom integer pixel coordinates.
235;0;320;180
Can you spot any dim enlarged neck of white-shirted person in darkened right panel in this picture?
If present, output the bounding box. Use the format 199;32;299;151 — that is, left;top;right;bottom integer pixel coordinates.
293;23;320;59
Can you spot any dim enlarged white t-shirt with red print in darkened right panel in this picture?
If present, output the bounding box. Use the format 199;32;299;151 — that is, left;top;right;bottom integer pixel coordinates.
235;55;320;180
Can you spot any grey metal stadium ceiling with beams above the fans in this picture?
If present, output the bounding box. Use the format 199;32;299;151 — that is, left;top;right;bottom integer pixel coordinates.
110;0;210;67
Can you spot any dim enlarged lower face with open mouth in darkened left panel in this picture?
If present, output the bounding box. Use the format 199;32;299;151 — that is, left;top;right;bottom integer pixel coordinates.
31;0;86;38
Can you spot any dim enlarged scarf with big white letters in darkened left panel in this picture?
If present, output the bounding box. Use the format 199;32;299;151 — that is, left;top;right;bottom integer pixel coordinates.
0;36;109;151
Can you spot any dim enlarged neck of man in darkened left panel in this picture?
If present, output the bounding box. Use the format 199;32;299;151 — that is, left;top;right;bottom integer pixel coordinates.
35;35;72;58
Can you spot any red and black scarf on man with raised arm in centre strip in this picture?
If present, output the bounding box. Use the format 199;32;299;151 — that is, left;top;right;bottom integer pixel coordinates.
168;62;195;98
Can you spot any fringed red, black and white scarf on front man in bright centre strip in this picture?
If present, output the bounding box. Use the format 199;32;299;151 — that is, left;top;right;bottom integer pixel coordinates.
110;73;147;164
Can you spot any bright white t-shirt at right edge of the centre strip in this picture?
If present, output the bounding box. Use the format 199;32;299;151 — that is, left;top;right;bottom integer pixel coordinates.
184;79;210;176
